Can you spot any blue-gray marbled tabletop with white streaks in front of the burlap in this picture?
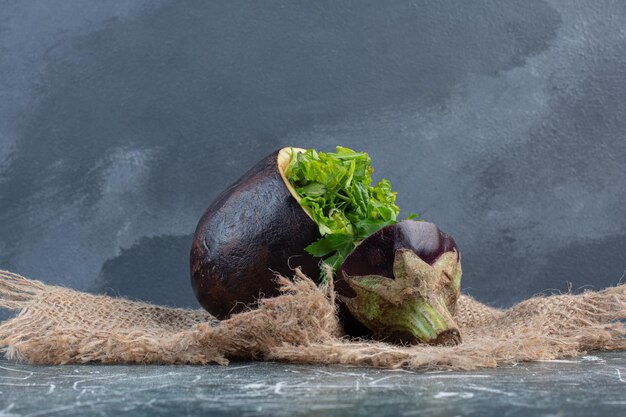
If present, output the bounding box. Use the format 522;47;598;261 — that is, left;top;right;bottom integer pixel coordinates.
0;352;626;417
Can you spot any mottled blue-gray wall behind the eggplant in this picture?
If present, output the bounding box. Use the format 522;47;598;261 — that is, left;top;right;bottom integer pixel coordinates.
0;0;626;306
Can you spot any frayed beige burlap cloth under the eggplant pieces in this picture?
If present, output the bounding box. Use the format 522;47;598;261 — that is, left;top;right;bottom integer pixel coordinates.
0;271;626;370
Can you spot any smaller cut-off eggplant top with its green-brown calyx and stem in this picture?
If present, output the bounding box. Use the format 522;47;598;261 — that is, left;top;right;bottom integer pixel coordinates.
335;220;462;344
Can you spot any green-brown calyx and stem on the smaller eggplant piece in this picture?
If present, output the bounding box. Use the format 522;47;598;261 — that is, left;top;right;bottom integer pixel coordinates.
340;249;461;345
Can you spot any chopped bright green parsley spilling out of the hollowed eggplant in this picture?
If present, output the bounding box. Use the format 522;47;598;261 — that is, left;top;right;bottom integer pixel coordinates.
285;146;402;281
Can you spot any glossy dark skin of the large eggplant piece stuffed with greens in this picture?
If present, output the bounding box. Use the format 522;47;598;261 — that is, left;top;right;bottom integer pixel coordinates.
190;150;320;319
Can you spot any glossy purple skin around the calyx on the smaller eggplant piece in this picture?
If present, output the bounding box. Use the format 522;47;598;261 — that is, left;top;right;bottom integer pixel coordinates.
335;220;458;337
